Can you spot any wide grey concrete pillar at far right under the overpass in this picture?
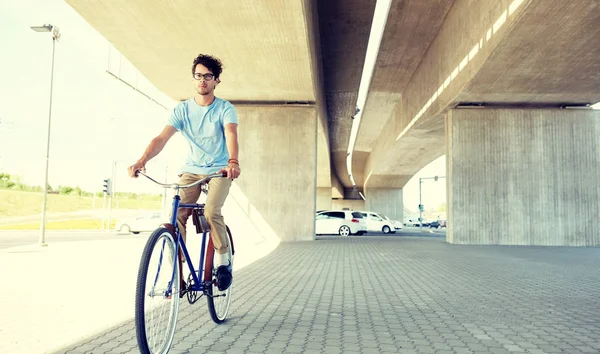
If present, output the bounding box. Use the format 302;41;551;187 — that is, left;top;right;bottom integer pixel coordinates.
446;109;600;246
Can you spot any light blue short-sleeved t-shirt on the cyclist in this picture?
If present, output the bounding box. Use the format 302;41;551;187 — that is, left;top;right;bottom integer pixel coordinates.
167;97;238;174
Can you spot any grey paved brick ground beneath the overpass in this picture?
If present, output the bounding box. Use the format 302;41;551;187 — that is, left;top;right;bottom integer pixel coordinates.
61;236;600;354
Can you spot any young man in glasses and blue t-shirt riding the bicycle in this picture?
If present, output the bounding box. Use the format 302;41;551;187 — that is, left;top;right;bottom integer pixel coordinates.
128;54;240;290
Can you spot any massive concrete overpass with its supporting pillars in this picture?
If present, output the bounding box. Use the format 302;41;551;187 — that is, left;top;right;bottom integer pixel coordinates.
67;0;600;246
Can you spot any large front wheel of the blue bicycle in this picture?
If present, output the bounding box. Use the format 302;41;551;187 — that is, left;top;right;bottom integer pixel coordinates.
135;227;180;354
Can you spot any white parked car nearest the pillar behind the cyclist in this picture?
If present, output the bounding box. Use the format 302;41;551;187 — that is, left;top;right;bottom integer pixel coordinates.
315;210;367;236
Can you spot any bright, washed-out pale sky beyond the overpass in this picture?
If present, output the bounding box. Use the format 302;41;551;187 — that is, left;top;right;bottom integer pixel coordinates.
0;0;600;211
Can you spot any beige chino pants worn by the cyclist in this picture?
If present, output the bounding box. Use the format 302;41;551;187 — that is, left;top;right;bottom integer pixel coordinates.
172;173;232;254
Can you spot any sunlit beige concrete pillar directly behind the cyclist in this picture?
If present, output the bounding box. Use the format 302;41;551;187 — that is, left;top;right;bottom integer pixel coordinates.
224;105;318;242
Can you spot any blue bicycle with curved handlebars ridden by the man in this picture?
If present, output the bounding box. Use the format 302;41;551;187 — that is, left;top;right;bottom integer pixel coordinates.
135;171;235;354
